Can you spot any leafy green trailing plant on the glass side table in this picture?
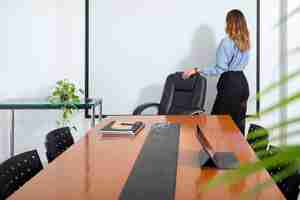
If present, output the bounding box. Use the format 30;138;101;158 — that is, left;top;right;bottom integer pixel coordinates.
49;79;84;130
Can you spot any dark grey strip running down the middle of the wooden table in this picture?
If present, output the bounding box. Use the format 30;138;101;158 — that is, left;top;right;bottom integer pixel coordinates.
119;124;180;200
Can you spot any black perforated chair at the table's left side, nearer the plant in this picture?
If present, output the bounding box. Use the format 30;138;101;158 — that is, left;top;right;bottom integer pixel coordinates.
45;127;74;163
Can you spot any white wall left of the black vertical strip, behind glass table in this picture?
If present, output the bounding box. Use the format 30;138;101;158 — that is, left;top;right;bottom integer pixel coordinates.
0;0;87;162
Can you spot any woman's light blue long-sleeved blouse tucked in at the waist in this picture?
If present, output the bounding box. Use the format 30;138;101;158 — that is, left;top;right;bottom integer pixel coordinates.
200;36;250;76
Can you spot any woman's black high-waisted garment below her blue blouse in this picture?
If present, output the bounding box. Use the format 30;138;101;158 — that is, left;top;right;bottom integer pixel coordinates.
212;71;249;134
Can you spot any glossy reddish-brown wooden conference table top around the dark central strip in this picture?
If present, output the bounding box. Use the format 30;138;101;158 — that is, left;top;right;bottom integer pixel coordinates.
9;116;284;200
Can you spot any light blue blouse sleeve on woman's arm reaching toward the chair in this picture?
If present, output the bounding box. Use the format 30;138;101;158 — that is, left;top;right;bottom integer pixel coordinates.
200;38;234;76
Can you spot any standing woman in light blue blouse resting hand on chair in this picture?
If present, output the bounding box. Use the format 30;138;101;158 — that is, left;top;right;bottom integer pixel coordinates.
183;10;250;133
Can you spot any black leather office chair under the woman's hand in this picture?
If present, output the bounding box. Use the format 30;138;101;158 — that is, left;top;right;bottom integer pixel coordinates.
133;72;207;115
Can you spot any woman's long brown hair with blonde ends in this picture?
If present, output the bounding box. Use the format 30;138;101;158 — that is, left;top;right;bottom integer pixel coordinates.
226;9;250;52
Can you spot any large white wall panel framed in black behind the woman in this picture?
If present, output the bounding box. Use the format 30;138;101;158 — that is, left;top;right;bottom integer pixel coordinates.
90;0;257;115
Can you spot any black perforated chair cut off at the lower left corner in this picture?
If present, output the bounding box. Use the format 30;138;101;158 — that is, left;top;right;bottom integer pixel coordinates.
0;150;43;200
